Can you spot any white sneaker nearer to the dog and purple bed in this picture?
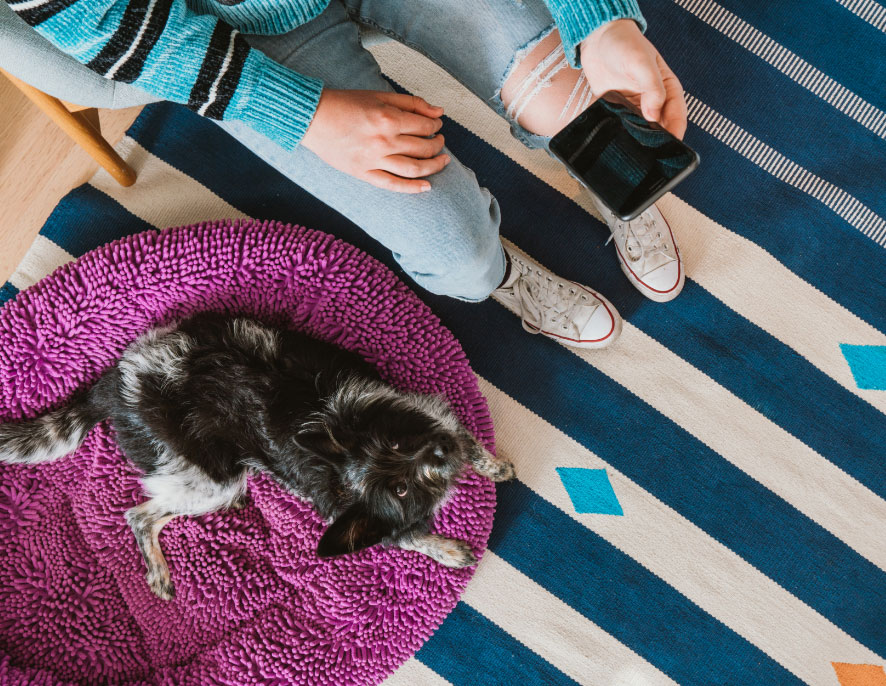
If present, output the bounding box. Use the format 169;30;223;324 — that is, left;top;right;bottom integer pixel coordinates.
492;245;621;348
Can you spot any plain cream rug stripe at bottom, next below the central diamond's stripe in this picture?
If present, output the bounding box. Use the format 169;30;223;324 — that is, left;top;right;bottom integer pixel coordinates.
464;550;675;686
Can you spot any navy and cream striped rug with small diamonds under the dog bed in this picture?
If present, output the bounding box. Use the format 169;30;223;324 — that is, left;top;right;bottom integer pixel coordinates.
2;0;886;686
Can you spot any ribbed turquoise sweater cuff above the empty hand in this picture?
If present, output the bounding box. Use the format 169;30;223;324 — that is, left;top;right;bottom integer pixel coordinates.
232;50;323;150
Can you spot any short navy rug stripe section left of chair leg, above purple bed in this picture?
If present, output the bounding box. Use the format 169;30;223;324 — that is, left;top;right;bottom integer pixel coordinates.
40;184;154;257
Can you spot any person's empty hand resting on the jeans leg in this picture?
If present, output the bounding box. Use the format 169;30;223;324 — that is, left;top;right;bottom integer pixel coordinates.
301;88;449;193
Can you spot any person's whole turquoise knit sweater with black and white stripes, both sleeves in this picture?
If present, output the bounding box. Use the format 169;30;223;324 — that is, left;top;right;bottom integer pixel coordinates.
6;0;645;150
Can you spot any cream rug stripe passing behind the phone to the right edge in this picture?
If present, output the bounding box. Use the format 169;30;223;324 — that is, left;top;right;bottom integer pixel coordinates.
373;41;886;412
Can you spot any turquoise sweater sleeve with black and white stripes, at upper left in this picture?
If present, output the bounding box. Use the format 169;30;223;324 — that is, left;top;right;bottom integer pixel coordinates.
6;0;323;150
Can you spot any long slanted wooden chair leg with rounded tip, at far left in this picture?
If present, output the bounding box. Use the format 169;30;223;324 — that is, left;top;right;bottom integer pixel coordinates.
0;69;135;186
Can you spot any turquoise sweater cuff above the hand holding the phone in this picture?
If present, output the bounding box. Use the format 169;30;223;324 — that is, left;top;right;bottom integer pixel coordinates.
547;0;646;69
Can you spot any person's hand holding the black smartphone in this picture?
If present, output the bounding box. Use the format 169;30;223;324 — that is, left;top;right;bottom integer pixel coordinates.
581;19;687;138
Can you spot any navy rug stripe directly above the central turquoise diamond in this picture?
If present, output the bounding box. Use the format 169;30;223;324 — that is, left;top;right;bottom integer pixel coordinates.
429;298;886;654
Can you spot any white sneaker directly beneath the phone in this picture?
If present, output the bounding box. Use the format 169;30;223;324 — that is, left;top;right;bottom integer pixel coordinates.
594;198;685;302
